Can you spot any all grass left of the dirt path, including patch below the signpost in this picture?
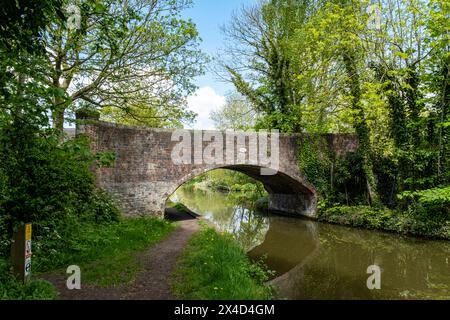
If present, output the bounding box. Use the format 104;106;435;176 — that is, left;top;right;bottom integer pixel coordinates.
0;218;175;299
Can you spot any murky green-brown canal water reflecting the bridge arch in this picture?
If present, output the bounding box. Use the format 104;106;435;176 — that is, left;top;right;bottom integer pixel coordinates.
172;188;450;299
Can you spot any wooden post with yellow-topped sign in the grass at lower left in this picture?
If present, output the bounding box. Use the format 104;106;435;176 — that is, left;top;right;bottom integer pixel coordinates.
11;223;32;282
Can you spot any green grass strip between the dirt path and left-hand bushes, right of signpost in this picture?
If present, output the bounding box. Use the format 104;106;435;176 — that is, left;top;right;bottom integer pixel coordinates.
35;217;175;287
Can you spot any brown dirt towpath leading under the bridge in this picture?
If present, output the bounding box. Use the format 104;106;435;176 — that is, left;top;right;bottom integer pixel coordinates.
44;212;198;300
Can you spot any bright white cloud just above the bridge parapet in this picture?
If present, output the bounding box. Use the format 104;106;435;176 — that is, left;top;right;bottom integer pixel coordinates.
187;86;225;129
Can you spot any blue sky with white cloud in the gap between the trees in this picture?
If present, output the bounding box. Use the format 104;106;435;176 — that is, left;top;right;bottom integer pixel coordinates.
182;0;256;129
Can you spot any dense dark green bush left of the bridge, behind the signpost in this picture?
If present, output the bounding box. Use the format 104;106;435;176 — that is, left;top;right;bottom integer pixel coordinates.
0;129;120;253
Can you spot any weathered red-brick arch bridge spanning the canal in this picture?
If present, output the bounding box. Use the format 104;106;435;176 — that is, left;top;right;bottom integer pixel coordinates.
76;120;356;217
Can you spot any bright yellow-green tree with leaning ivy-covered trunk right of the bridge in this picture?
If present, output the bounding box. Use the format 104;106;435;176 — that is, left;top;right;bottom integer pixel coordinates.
284;1;377;203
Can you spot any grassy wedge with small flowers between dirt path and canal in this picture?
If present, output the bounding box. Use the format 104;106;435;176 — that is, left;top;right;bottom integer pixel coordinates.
172;226;272;300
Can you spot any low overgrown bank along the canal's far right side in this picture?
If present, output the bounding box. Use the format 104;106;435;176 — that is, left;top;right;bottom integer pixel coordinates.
318;206;450;240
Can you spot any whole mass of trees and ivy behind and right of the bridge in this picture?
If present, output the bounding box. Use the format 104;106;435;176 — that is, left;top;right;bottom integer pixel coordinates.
222;0;450;224
